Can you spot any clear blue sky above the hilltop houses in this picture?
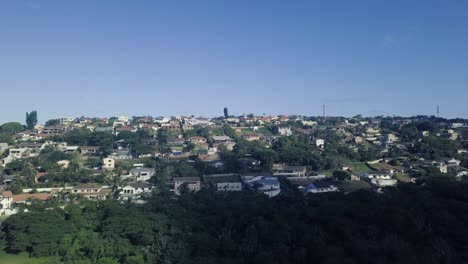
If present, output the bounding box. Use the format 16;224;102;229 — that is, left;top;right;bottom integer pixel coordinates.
0;0;468;122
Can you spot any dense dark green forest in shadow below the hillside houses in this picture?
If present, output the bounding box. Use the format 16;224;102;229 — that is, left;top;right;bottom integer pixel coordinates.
2;178;468;264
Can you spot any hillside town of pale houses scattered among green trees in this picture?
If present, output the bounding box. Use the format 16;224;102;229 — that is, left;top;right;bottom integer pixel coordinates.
0;109;468;215
